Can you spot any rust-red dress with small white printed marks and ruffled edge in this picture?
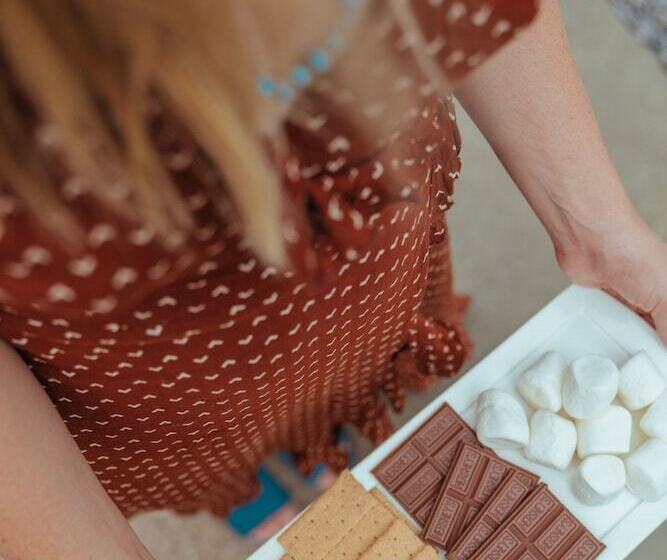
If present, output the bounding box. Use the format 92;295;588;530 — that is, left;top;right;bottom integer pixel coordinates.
0;0;535;515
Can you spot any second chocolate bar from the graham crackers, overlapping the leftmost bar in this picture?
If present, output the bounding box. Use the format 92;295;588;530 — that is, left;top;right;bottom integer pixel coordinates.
422;443;538;551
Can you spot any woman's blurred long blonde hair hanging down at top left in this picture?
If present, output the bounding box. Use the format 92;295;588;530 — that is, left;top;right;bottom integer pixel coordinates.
0;0;452;264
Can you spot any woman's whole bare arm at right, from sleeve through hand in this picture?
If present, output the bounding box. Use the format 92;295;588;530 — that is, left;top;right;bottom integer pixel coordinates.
457;0;667;342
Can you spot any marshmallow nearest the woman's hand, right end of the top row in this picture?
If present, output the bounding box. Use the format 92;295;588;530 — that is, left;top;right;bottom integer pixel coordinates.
618;350;665;410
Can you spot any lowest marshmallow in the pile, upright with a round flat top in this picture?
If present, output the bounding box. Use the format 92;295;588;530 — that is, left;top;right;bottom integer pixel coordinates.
574;455;625;506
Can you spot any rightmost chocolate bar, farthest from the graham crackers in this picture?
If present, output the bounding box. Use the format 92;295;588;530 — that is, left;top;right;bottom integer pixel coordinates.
472;484;604;560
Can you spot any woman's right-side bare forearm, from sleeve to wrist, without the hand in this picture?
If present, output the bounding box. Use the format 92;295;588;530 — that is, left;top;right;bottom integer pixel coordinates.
457;0;645;258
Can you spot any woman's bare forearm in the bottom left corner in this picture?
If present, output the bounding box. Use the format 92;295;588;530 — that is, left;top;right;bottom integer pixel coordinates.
0;342;150;560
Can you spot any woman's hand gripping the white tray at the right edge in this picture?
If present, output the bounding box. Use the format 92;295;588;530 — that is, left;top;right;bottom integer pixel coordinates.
556;218;667;345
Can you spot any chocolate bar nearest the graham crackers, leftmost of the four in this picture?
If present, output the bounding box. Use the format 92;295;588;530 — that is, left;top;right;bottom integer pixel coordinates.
373;404;481;526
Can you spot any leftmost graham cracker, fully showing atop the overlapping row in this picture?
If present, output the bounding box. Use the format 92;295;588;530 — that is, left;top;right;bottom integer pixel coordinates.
278;471;377;560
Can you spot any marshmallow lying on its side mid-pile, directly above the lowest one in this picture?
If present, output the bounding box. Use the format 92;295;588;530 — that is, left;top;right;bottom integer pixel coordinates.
577;405;632;459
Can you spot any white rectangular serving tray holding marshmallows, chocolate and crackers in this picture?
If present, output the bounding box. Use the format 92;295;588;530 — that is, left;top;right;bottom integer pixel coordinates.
250;286;667;560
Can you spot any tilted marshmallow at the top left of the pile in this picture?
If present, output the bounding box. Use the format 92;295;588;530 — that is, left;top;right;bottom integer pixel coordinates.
517;352;567;412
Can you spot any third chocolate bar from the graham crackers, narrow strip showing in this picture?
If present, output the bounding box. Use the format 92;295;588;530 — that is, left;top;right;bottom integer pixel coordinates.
447;471;538;560
